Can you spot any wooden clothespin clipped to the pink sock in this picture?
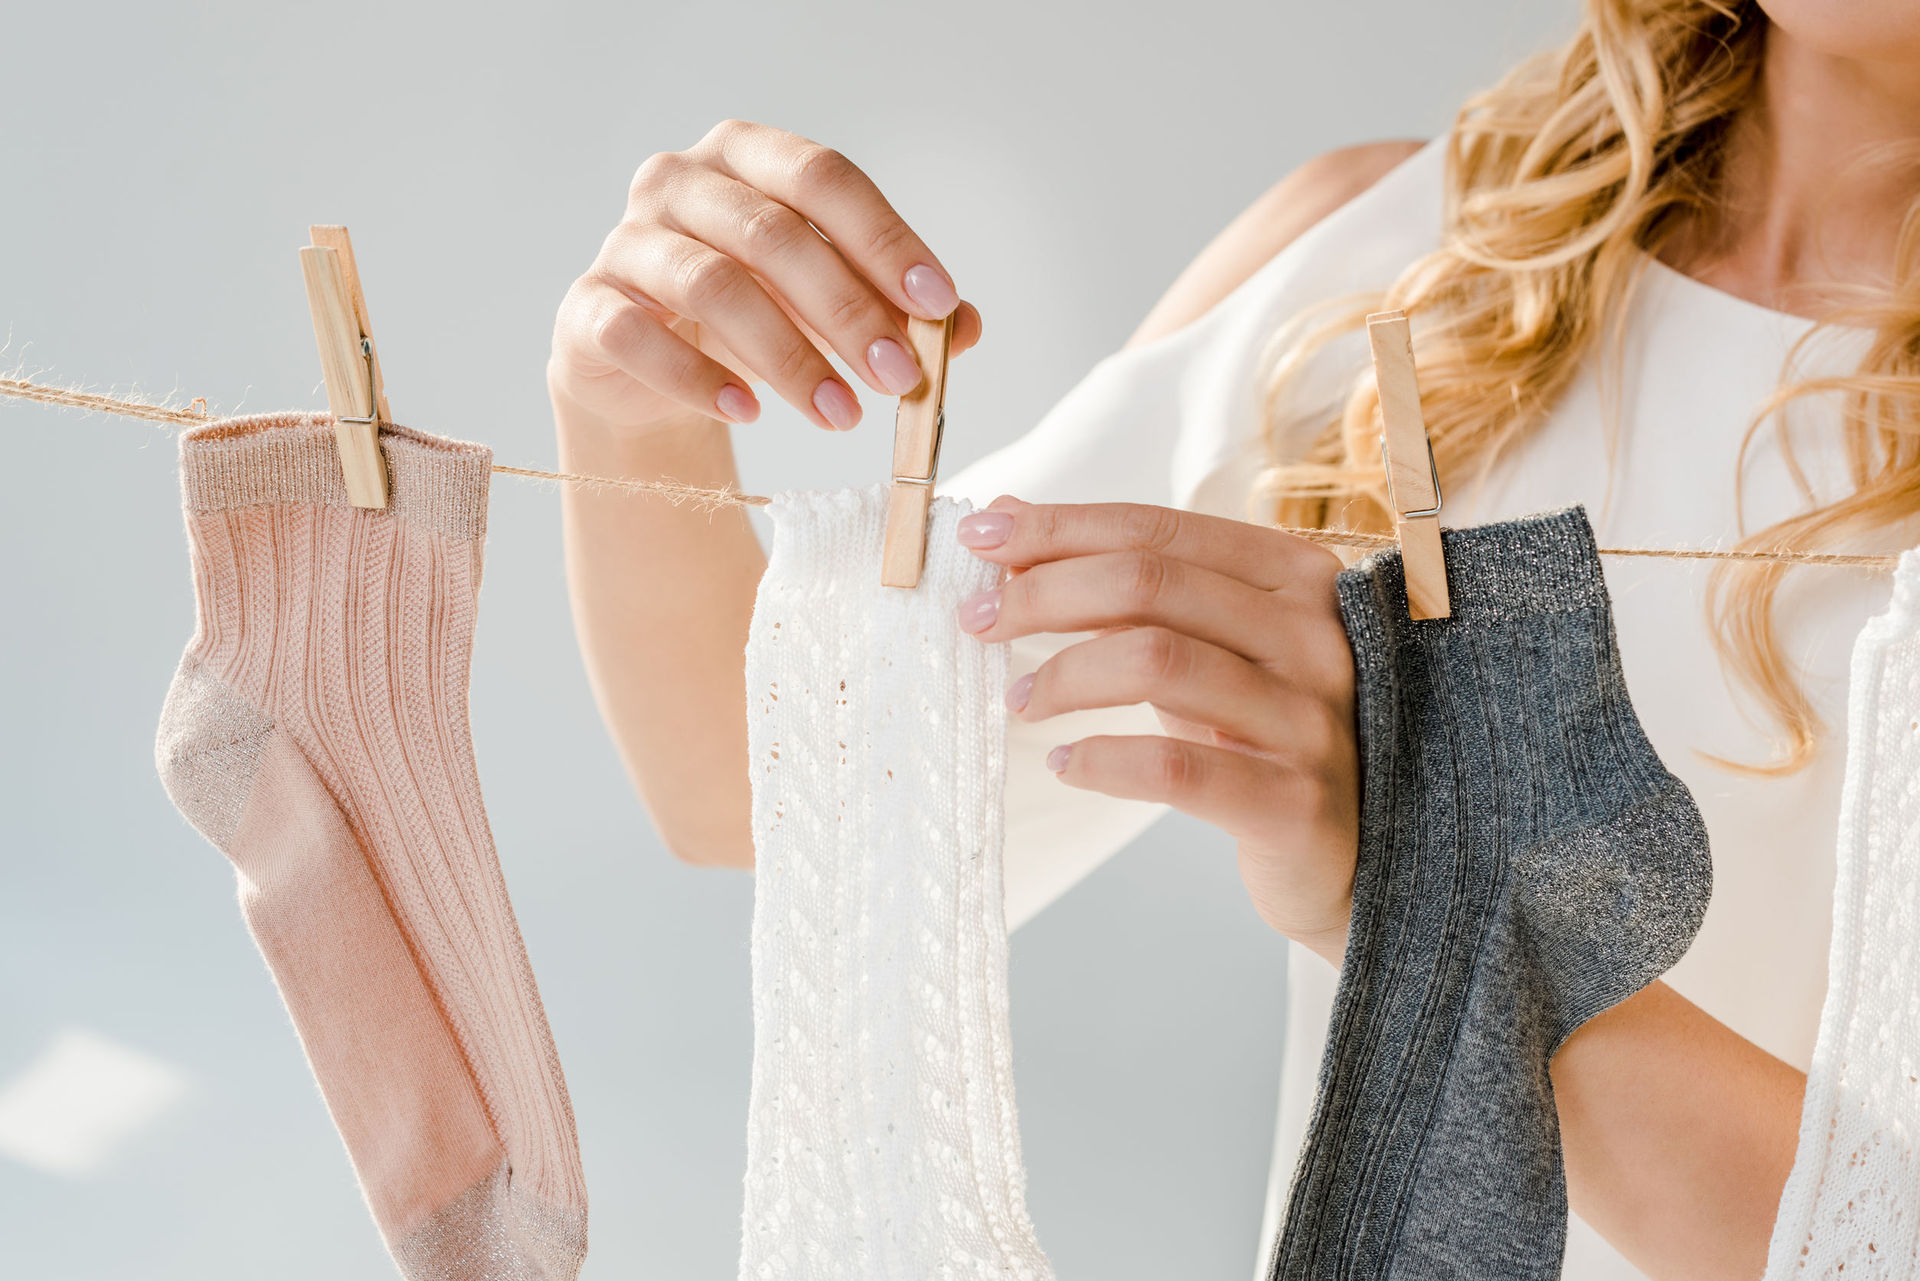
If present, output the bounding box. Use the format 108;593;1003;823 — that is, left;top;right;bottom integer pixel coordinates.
300;227;394;507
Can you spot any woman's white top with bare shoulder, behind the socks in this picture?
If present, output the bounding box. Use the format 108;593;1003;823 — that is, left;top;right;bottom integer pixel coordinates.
941;140;1916;1281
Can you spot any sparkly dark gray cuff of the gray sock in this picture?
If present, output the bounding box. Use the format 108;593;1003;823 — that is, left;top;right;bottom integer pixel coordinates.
1338;505;1607;647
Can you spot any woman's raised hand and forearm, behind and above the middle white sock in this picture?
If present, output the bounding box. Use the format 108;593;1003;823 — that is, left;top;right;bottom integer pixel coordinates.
547;121;981;866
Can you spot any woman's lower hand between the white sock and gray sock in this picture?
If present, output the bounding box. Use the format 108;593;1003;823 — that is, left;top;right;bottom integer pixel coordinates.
958;497;1359;966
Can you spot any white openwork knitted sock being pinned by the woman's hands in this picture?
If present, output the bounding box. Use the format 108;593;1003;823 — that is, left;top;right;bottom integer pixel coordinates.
739;486;1052;1281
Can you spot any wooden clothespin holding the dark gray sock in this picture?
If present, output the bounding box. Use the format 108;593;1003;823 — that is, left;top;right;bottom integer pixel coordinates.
1367;311;1453;618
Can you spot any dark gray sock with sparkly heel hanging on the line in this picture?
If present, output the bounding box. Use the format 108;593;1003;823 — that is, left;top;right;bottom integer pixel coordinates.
1269;507;1713;1281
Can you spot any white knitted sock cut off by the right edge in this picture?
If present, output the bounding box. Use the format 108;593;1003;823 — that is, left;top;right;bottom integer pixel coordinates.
1766;549;1920;1281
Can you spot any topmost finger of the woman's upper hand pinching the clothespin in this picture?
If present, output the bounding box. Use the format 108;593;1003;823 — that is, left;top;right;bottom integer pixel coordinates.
693;119;960;321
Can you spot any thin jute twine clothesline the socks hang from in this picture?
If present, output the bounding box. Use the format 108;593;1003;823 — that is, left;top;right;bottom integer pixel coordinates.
0;370;1899;570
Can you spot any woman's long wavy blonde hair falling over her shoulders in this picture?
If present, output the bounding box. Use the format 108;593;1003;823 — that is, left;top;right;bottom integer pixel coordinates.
1256;0;1920;774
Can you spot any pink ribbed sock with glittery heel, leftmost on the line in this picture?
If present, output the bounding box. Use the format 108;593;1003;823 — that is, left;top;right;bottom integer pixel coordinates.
156;415;586;1281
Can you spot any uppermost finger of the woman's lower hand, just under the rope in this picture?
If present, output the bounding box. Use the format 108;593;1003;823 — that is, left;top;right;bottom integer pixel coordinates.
958;497;1340;593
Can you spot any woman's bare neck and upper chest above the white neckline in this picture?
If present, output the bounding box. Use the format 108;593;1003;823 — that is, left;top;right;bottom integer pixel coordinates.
1661;27;1920;315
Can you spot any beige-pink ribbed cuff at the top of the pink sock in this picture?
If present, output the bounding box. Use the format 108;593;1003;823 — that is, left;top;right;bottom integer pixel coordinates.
180;413;493;542
